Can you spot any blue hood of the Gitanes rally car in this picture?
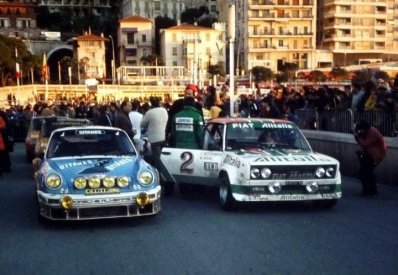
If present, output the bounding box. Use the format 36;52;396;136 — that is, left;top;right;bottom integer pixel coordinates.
47;156;141;178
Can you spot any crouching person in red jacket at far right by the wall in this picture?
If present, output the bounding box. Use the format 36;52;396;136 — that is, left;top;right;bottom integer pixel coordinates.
354;121;387;196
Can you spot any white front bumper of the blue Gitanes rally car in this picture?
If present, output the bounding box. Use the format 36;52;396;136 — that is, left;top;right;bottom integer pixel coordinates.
37;186;161;220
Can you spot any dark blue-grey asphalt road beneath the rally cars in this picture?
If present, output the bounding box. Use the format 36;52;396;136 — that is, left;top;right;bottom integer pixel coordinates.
0;144;398;275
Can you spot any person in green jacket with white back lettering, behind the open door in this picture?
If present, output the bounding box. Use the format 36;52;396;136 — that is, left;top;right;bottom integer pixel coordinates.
172;97;204;149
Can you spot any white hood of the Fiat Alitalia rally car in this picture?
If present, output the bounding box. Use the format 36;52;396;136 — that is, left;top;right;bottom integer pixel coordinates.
232;149;338;165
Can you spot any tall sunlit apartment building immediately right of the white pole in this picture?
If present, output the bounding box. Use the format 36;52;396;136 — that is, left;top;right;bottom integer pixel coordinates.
232;0;317;72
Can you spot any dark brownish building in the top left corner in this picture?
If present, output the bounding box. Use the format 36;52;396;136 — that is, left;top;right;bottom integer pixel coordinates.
0;0;40;38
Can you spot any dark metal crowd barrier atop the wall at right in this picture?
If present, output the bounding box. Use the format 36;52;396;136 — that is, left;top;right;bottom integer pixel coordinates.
296;109;398;137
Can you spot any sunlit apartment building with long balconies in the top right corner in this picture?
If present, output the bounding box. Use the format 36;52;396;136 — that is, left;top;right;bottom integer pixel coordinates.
318;0;398;66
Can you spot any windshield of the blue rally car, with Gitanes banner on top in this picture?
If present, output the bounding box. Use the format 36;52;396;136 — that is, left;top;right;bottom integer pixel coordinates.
47;128;136;158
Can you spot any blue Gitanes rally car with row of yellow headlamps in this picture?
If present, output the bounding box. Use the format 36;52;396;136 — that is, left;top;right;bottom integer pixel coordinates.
35;126;161;222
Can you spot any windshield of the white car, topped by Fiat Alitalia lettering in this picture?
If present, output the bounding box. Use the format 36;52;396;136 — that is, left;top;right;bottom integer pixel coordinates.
226;121;311;151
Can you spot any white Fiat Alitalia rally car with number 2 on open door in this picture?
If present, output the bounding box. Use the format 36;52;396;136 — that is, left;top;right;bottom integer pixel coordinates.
162;118;342;210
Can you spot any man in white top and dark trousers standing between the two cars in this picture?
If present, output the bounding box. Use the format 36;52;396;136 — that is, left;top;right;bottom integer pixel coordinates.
141;97;174;195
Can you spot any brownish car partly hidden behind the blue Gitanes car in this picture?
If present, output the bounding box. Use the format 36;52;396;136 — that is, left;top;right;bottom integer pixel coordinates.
33;116;92;171
